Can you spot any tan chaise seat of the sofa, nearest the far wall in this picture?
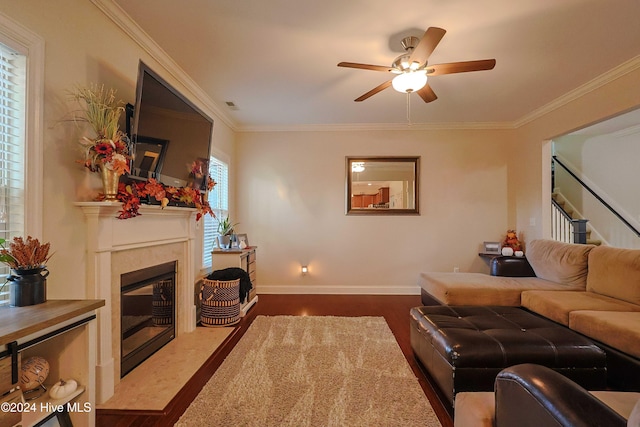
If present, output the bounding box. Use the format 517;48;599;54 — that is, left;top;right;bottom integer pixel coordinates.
418;273;567;307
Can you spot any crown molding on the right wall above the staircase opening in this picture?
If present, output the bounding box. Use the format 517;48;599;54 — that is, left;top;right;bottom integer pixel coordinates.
514;55;640;128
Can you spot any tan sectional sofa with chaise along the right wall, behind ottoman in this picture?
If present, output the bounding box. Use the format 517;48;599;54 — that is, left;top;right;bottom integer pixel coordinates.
419;240;640;424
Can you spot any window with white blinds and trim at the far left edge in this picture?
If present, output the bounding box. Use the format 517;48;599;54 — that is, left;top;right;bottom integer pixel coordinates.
0;14;44;305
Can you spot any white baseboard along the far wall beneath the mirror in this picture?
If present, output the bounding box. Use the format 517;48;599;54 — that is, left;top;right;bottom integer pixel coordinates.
258;285;420;295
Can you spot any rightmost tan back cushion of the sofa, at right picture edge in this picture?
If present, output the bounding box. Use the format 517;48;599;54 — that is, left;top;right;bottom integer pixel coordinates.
587;246;640;304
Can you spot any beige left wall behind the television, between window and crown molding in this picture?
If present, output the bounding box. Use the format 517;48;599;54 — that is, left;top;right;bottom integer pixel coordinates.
0;0;234;298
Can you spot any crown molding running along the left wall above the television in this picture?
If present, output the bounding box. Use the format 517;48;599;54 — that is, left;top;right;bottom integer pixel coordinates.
91;0;238;131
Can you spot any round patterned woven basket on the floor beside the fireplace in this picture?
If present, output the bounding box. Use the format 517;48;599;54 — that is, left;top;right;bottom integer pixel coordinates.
200;279;240;326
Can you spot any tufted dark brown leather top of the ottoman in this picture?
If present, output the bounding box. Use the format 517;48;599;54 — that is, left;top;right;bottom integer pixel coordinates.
410;306;606;368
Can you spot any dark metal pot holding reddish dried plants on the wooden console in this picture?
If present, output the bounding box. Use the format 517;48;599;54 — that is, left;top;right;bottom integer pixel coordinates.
7;267;49;307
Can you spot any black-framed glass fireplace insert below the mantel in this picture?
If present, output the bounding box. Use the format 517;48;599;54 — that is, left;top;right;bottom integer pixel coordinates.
120;261;177;378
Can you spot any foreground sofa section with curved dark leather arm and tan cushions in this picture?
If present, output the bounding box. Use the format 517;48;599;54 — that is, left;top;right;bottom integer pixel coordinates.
454;364;640;427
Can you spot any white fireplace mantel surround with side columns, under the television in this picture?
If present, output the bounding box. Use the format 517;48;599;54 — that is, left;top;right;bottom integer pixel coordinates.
76;202;197;403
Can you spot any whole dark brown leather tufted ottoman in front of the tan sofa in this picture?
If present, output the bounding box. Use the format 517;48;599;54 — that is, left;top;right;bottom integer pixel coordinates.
410;306;607;405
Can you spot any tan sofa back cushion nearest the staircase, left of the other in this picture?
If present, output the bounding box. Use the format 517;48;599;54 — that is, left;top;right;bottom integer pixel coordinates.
527;240;595;289
